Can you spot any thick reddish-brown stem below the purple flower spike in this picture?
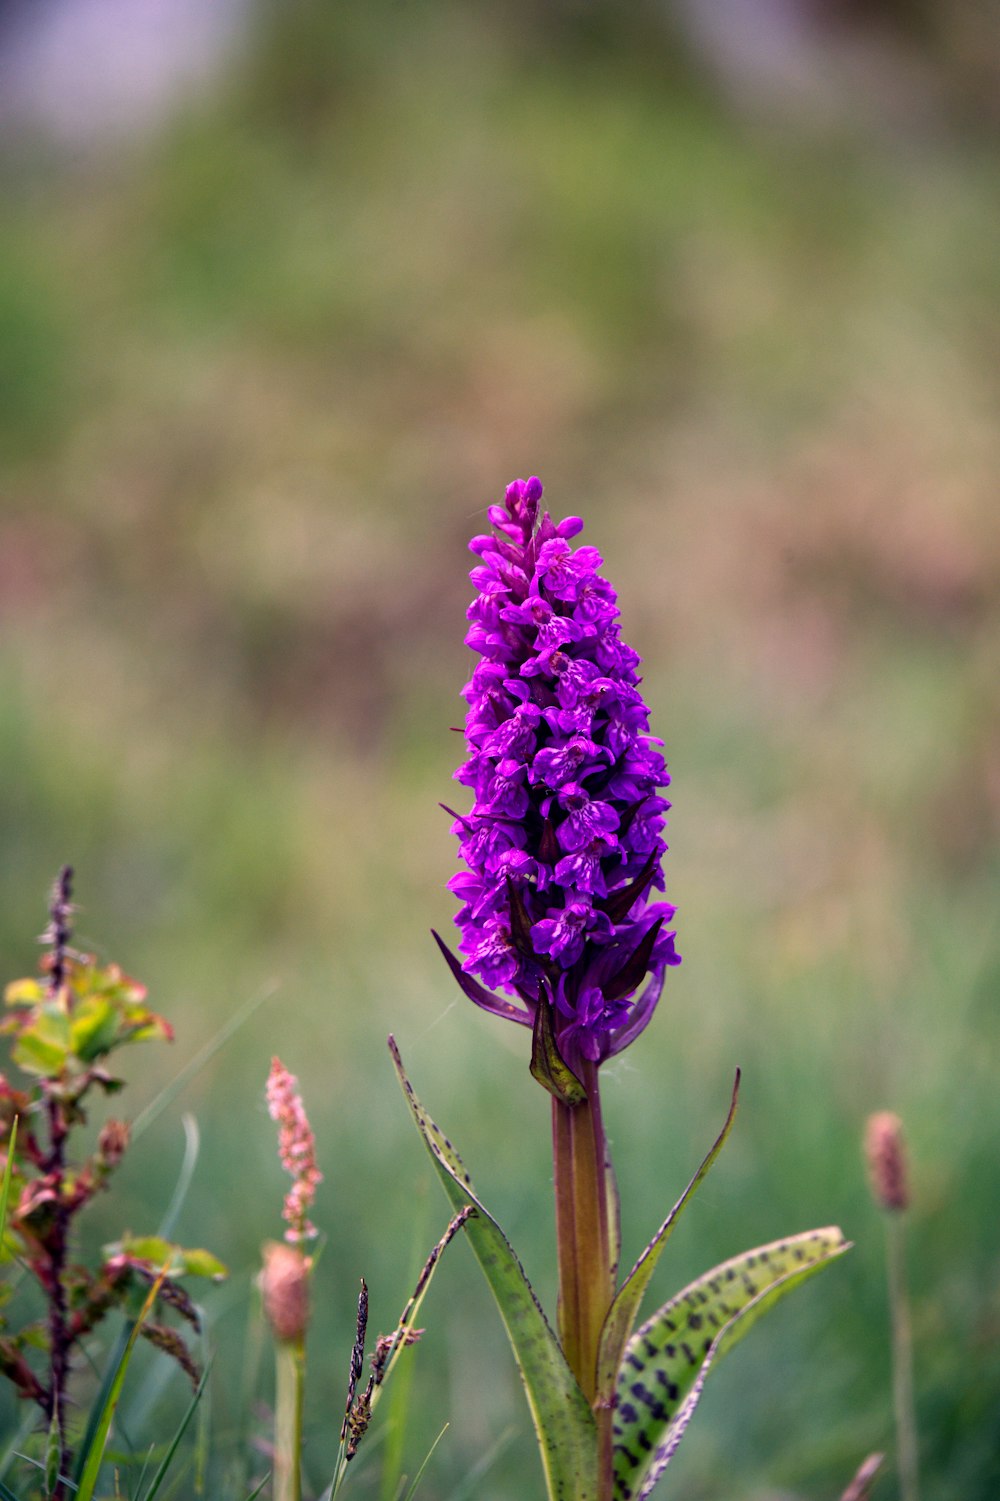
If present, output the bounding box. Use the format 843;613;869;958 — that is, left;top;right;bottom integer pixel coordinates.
553;1063;614;1402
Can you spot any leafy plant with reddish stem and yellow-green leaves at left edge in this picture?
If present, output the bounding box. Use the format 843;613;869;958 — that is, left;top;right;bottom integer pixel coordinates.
0;866;225;1501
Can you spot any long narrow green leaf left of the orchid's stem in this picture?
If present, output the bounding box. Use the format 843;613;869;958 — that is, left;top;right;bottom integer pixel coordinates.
389;1037;598;1501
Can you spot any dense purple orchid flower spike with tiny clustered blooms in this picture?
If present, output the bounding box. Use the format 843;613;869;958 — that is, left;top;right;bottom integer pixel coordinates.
438;477;680;1072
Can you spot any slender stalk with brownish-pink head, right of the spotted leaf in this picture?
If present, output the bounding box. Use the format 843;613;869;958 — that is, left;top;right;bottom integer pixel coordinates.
865;1111;920;1501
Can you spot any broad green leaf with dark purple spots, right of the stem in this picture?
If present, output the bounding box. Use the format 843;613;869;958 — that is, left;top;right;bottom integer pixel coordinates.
614;1226;850;1501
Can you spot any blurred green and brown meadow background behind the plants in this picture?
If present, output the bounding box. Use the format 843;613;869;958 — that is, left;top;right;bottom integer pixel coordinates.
0;0;1000;1501
